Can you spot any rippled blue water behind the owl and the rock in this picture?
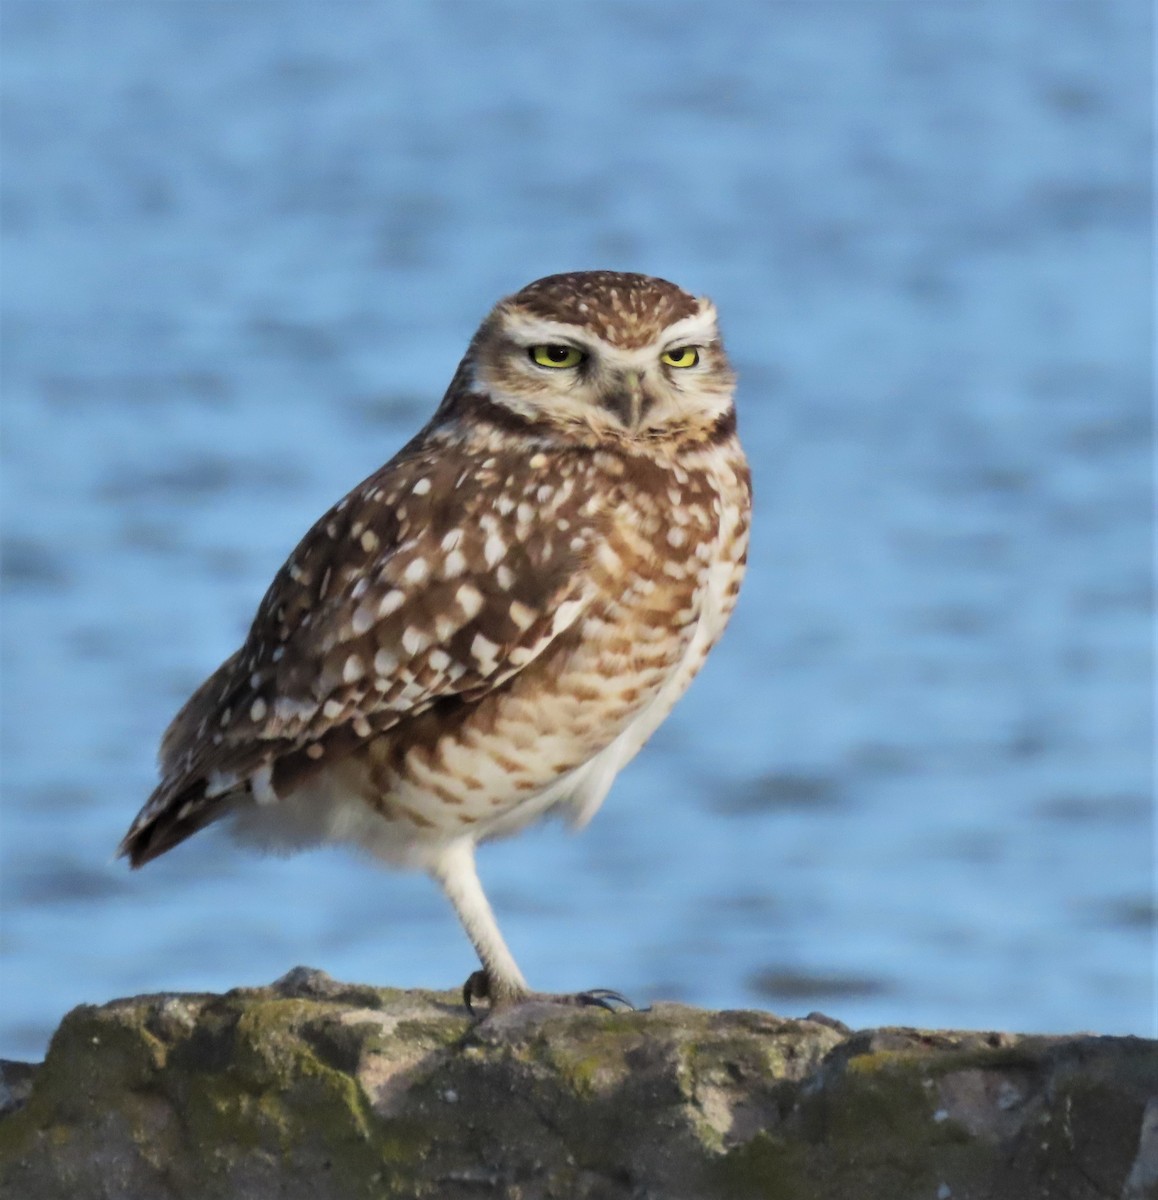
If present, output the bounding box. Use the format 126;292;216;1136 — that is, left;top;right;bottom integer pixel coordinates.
0;0;1156;1057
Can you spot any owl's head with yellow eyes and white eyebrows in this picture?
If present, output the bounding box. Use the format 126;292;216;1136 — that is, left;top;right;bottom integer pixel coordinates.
460;271;736;443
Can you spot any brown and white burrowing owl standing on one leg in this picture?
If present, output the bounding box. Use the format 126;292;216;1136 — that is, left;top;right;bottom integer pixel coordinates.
120;271;750;1007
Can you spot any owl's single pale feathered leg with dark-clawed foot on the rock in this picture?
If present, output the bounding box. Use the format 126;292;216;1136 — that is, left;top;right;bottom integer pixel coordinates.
431;841;635;1012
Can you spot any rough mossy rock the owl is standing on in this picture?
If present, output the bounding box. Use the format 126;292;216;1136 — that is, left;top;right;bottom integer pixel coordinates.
0;967;1158;1200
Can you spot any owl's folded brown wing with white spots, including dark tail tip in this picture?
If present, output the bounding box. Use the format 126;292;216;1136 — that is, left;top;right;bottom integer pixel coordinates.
121;440;599;865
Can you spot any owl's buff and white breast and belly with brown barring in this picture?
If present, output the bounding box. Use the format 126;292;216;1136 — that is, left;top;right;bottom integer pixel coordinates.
279;436;746;840
